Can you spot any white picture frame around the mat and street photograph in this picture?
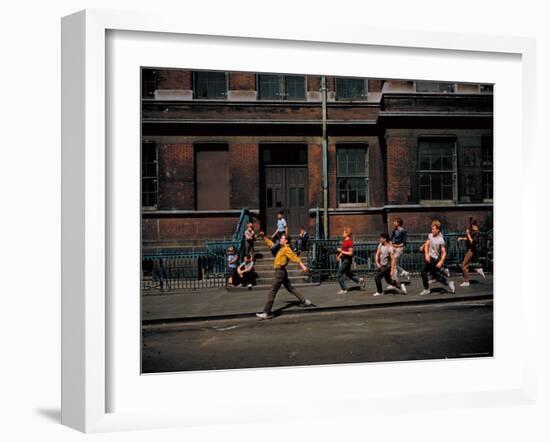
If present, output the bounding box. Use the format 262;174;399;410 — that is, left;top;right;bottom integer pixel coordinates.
62;10;537;432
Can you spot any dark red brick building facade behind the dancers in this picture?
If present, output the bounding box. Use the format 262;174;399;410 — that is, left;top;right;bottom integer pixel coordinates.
142;69;493;244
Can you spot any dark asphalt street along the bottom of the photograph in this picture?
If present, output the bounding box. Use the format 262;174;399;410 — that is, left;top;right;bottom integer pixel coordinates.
142;299;493;373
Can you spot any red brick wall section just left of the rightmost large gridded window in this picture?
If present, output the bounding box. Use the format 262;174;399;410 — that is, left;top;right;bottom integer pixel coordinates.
386;137;411;204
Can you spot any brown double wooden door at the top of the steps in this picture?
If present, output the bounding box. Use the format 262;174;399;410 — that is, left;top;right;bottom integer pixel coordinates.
264;166;309;236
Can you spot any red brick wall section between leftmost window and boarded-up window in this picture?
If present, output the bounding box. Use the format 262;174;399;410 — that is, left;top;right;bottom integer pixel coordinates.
158;144;195;210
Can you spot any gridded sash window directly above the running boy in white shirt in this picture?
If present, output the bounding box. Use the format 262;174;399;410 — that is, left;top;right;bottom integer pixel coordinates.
418;139;456;201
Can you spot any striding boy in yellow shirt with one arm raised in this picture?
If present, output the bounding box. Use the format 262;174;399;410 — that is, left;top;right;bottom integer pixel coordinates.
256;232;312;319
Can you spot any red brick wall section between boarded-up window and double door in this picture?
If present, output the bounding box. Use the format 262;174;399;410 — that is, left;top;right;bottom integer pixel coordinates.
229;143;260;209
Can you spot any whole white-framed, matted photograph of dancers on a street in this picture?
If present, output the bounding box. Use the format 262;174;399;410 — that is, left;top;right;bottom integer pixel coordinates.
62;11;536;432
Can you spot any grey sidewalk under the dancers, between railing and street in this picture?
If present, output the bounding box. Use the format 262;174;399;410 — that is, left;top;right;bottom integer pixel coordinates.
142;275;493;325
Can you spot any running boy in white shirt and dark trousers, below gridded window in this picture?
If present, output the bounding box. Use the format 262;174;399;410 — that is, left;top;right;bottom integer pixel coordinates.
420;220;455;295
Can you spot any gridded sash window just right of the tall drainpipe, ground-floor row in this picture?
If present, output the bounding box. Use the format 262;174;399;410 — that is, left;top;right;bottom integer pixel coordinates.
336;144;369;205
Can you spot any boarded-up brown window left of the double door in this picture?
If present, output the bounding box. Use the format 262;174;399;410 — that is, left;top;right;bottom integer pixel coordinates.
195;144;229;210
